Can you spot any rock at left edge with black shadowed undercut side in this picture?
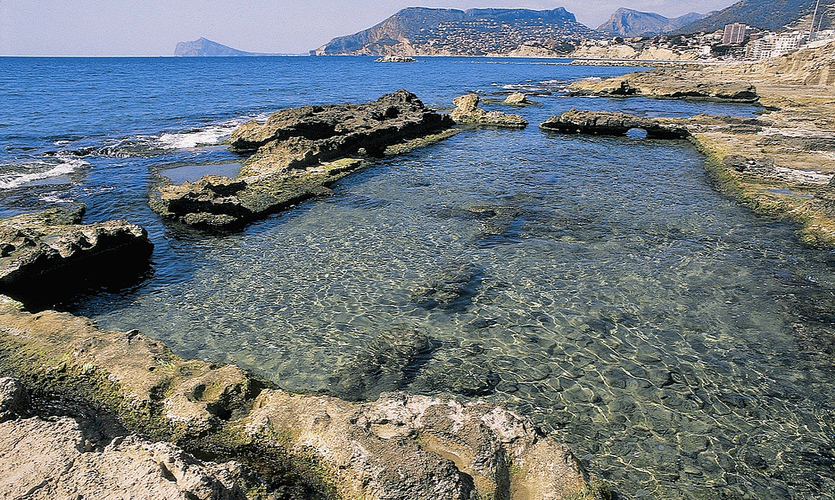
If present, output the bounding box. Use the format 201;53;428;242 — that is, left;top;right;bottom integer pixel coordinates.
0;205;153;305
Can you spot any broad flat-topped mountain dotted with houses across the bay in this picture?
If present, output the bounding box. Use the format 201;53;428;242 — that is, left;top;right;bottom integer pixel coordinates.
311;7;601;56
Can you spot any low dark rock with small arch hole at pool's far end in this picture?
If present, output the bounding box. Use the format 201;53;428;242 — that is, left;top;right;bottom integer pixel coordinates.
539;109;690;139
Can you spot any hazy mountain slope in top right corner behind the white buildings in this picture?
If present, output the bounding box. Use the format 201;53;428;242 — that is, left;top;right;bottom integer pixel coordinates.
675;0;835;33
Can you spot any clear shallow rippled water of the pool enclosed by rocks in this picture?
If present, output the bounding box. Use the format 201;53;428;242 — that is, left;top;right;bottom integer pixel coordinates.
83;128;835;499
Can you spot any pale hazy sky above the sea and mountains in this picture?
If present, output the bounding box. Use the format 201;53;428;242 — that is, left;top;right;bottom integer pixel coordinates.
0;0;735;55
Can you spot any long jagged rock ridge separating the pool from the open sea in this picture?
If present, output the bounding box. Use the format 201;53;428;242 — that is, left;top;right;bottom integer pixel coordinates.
151;90;460;228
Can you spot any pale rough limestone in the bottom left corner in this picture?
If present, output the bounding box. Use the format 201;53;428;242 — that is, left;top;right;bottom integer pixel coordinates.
0;417;253;500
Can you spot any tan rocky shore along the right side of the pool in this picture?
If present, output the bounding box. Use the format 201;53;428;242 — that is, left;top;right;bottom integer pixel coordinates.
555;40;835;246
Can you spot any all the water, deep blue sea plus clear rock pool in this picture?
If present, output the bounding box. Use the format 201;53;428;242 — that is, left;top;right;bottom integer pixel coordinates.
0;57;835;500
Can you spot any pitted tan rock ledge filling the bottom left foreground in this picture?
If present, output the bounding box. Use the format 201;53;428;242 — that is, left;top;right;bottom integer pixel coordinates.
0;297;609;500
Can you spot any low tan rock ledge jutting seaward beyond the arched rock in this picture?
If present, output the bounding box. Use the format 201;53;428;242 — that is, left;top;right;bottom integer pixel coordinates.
568;68;759;103
